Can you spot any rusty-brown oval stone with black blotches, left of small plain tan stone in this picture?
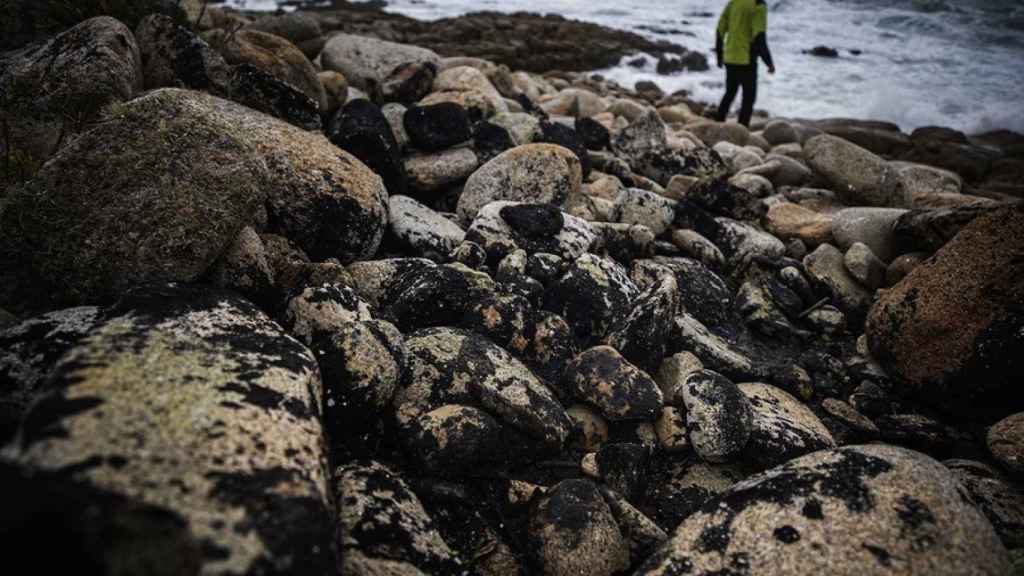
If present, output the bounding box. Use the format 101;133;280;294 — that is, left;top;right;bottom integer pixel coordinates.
562;345;664;421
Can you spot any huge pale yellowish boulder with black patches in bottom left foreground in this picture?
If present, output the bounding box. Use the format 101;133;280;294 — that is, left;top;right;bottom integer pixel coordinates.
15;285;335;574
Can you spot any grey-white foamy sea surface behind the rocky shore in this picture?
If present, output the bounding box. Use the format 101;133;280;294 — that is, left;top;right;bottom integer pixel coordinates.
228;0;1024;133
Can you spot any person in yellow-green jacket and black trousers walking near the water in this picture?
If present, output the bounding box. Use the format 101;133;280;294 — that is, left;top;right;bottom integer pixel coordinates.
715;0;775;127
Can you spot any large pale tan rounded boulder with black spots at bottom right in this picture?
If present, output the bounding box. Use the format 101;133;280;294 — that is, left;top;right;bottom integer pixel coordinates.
636;445;1010;576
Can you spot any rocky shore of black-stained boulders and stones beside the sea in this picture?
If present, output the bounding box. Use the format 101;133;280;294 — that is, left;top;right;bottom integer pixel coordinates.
0;0;1024;576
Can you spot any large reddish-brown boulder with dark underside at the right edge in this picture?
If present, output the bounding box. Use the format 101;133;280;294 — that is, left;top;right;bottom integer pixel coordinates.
866;206;1024;415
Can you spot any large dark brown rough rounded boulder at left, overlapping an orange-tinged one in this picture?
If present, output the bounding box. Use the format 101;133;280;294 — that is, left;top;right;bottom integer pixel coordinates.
0;90;268;307
